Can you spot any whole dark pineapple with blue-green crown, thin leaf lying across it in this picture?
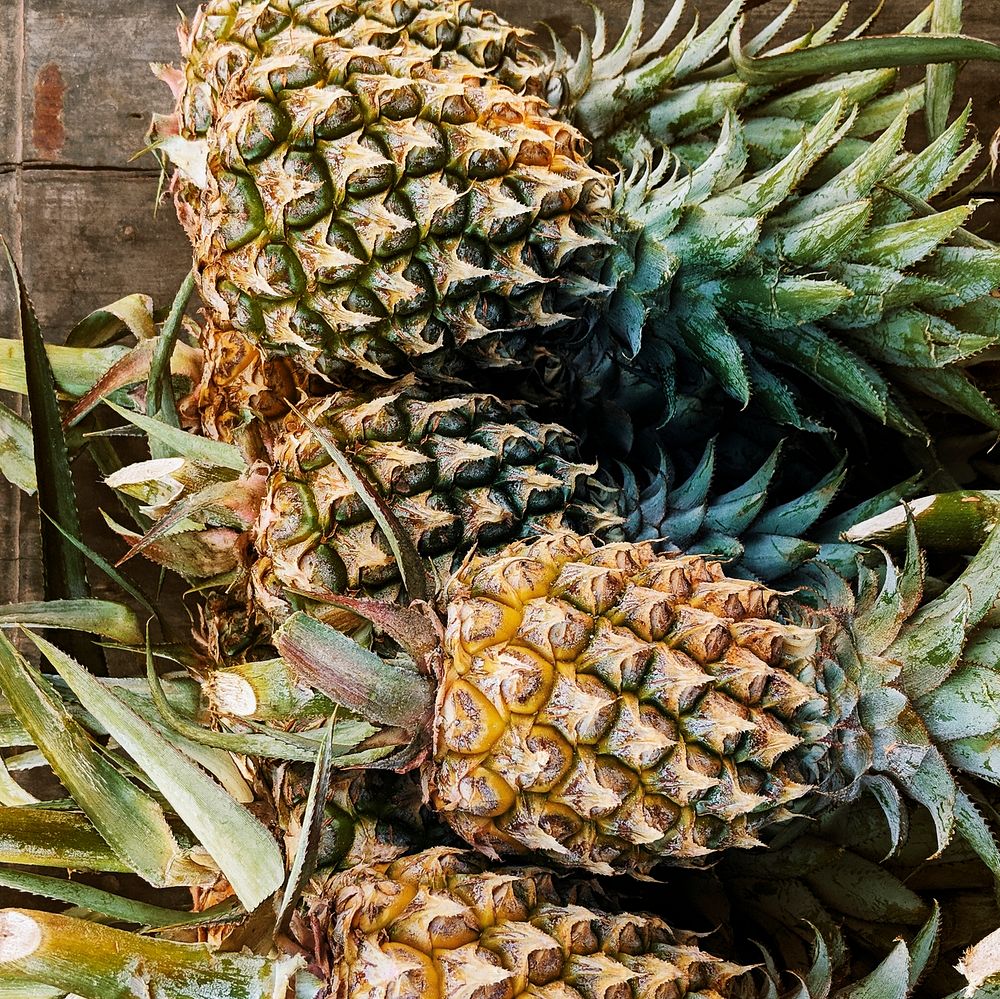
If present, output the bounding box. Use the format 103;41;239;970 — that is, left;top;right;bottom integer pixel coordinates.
107;368;896;648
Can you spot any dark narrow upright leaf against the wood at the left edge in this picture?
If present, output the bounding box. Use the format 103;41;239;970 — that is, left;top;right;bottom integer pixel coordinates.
3;242;107;674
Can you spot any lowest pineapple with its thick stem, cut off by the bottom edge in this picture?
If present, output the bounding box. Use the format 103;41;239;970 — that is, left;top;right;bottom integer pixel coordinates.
0;850;940;999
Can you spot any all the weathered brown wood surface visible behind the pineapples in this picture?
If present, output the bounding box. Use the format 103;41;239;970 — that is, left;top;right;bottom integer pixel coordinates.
0;0;1000;601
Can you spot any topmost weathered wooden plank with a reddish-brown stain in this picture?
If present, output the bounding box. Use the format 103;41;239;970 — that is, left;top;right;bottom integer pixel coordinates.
11;0;1000;167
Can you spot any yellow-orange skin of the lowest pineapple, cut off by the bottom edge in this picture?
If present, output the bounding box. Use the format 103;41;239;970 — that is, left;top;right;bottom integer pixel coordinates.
306;850;747;999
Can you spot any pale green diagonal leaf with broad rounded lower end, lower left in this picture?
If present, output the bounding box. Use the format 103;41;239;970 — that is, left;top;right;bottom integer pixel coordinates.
27;632;285;910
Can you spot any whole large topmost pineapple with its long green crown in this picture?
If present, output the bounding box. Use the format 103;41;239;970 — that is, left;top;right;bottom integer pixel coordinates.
157;0;1000;442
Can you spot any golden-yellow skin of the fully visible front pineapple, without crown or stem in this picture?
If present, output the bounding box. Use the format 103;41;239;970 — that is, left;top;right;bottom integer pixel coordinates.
427;532;827;873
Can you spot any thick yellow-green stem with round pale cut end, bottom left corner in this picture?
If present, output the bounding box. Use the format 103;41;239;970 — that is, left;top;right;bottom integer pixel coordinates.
0;909;300;999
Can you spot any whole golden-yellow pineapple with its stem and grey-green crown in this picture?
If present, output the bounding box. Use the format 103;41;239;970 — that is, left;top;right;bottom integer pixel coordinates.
180;532;1000;874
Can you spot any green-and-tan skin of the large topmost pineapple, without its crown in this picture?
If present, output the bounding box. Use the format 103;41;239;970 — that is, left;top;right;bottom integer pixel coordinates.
164;0;610;376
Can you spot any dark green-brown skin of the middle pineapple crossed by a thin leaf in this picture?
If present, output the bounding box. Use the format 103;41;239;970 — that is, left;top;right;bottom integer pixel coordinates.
250;382;615;617
